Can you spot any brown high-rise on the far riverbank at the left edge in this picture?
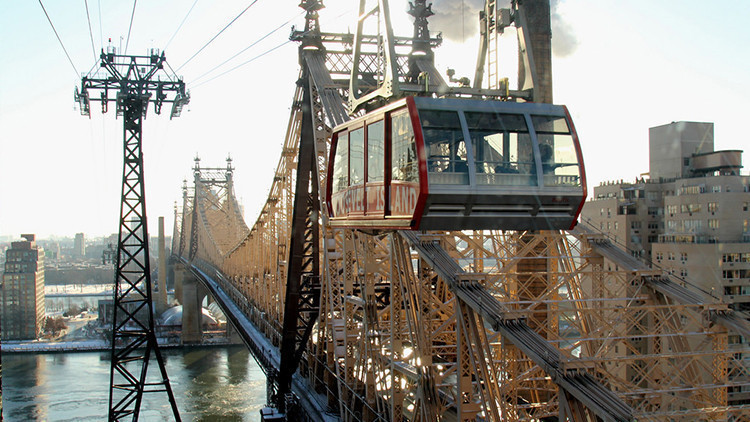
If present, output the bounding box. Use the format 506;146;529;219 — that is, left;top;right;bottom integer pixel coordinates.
0;234;44;340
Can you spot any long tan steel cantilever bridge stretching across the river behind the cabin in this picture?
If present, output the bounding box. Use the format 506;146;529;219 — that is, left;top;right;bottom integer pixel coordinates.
172;3;750;421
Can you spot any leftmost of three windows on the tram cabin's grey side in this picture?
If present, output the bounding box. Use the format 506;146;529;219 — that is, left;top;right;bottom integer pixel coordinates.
419;110;469;185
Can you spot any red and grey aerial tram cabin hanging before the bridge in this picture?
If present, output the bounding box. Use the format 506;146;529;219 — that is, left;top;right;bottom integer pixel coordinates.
326;97;586;230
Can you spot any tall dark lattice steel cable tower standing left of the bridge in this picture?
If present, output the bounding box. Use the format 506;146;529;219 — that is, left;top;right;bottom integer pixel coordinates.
75;47;190;421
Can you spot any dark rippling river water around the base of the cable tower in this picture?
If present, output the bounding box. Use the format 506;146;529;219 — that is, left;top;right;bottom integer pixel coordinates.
2;346;266;421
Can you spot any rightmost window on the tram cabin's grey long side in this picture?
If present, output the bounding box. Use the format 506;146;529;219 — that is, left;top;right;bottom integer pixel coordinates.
531;116;581;186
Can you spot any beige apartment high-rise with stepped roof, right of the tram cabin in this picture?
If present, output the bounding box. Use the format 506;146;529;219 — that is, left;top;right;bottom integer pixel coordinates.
581;122;750;405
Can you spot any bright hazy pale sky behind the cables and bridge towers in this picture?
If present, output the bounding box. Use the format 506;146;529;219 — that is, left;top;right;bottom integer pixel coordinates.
0;0;750;238
